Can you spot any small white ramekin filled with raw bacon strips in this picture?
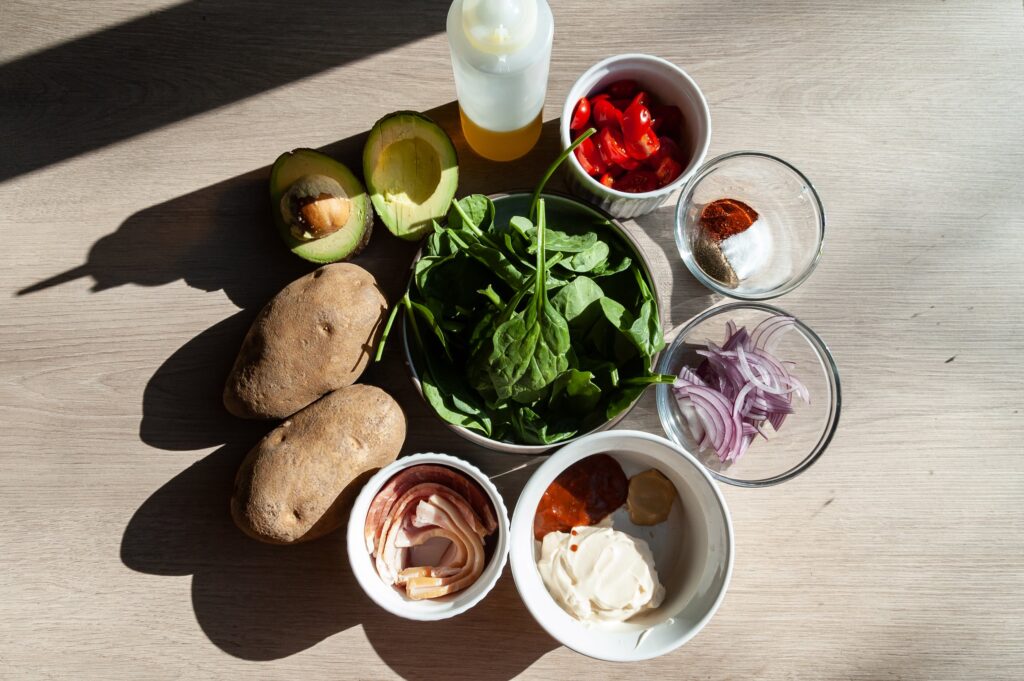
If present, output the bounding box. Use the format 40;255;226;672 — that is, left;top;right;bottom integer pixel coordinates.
347;454;509;621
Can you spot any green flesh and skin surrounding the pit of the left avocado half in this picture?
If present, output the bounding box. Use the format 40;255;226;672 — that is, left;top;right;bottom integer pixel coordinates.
270;148;374;262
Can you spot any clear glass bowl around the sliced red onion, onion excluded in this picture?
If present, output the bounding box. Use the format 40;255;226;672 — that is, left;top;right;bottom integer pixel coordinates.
656;303;842;487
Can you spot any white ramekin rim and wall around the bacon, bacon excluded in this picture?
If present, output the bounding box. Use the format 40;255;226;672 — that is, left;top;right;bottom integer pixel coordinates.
346;454;509;622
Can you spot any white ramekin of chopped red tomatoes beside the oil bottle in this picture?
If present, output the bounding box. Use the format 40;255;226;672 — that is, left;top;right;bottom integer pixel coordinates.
560;54;711;218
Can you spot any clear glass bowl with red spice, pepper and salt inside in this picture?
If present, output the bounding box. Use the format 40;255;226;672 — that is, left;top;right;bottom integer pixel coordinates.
676;152;825;300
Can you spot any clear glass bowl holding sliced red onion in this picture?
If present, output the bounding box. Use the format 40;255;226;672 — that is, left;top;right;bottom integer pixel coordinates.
657;303;842;487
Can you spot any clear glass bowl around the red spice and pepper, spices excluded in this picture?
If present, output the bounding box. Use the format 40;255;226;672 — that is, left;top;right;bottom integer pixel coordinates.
676;152;825;300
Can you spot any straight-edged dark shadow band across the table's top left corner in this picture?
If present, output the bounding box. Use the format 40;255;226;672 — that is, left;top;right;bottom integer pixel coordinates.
0;0;447;182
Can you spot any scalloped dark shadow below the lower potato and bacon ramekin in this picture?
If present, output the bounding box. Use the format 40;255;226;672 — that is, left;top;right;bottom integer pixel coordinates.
121;440;557;679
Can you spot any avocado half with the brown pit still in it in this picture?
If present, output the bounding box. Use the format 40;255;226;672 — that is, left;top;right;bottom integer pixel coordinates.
270;148;374;263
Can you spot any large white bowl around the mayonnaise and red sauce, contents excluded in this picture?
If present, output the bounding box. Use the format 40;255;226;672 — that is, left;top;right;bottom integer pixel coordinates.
510;430;733;662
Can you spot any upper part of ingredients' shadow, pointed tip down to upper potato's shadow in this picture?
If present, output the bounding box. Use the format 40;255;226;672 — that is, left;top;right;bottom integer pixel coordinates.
105;102;558;451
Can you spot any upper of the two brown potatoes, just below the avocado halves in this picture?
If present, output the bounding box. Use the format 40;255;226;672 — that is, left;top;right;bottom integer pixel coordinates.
224;263;387;419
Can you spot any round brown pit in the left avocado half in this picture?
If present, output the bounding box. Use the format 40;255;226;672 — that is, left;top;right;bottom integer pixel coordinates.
281;175;352;241
